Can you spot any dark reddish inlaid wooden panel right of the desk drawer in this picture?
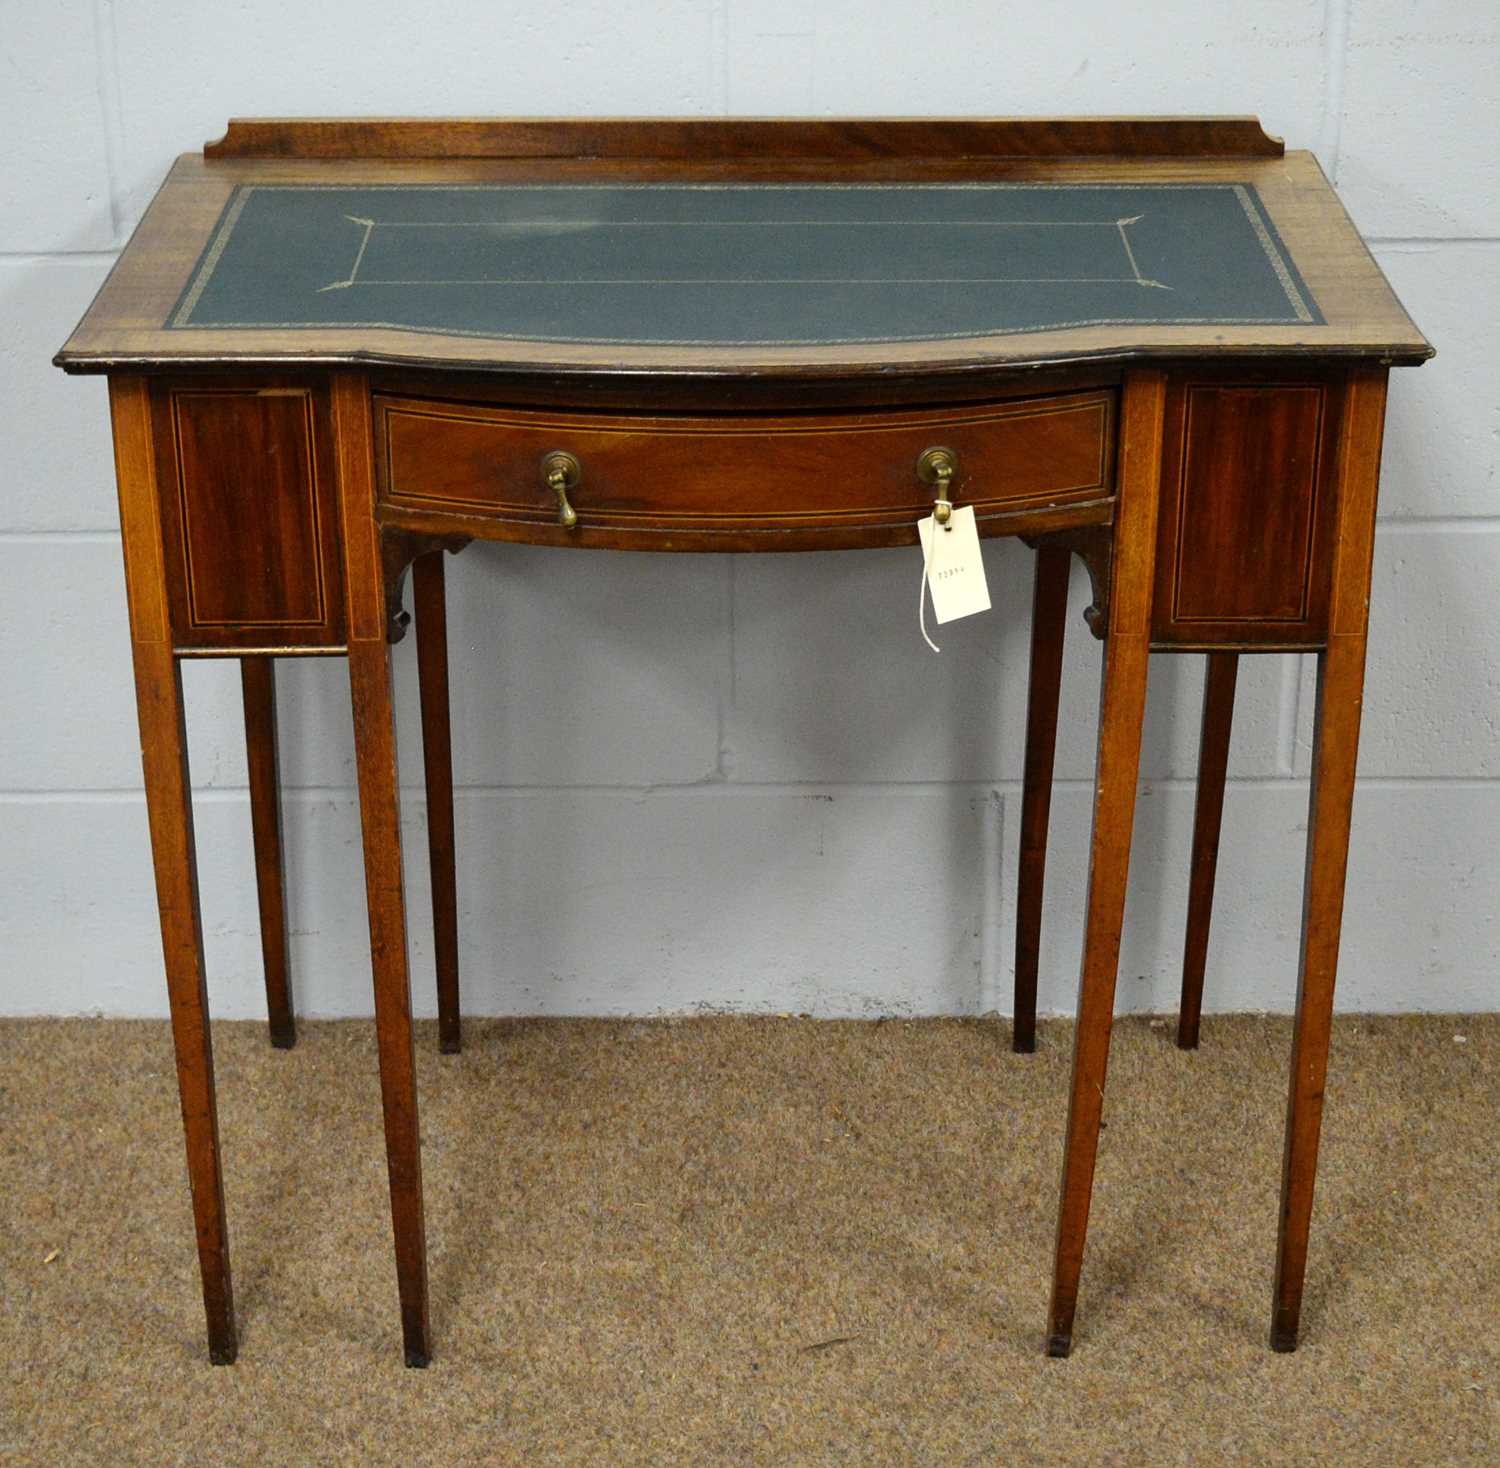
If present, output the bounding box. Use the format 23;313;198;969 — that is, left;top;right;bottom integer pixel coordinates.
1154;378;1343;646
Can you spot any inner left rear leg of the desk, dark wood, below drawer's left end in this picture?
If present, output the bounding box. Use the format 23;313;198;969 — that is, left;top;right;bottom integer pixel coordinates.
411;550;464;1054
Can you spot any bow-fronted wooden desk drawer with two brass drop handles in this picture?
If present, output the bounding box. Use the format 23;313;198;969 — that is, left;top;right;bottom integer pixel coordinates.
375;391;1115;549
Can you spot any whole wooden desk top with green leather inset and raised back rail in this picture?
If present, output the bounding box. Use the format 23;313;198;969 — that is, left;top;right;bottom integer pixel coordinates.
57;120;1431;376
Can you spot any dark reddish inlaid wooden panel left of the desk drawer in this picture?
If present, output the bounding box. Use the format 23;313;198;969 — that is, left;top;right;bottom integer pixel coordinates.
152;382;344;649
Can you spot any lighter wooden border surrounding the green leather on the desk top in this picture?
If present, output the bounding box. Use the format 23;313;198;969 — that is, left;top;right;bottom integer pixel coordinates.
57;123;1431;379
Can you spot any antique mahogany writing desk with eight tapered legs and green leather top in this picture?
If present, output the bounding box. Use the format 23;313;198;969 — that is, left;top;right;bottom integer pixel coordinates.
57;118;1431;1366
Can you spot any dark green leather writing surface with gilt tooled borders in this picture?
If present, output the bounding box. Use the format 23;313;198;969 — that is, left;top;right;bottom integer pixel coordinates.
167;183;1323;346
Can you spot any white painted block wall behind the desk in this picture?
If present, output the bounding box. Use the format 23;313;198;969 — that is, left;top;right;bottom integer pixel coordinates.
0;0;1500;1017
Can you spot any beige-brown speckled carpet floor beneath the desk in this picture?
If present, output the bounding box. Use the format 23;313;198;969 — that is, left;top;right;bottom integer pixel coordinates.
0;1017;1500;1468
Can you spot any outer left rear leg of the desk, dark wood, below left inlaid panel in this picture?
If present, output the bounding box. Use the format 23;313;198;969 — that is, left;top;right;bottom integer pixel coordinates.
240;657;297;1050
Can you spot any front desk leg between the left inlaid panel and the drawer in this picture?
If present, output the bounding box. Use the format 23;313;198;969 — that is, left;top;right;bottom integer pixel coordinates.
333;373;432;1366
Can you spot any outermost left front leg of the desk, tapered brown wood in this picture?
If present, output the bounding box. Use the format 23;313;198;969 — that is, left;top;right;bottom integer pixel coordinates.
110;376;239;1365
